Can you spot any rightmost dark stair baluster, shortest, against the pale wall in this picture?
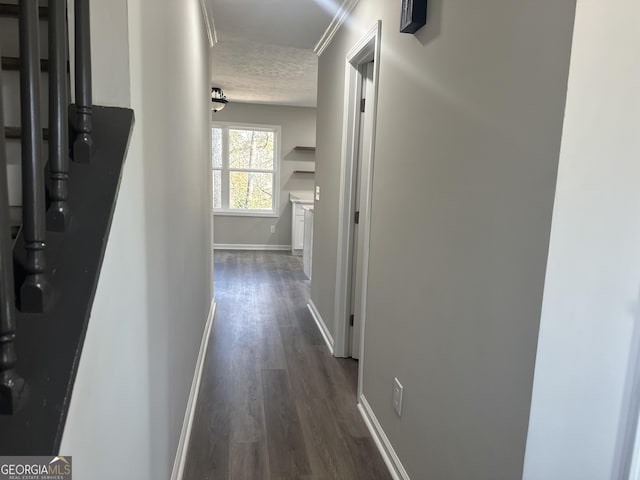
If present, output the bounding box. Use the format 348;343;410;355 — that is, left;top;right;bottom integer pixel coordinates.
73;0;93;163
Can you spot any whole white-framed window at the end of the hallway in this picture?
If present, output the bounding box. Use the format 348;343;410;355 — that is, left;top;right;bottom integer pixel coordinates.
211;123;280;216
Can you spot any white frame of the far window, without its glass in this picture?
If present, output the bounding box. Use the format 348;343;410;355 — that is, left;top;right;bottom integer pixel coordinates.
210;121;282;218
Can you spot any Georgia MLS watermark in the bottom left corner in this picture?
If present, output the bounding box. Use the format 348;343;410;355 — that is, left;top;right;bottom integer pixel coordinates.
0;457;71;480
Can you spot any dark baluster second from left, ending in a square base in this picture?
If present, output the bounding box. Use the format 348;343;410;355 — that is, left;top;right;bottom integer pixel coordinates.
20;0;49;312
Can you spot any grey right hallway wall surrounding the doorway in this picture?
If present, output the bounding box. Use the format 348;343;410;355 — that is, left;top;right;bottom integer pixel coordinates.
311;0;575;480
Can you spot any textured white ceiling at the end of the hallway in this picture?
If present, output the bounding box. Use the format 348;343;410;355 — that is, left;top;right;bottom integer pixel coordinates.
209;0;339;107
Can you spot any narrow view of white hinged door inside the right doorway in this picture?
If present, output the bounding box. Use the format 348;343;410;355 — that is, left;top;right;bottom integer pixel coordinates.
351;62;374;358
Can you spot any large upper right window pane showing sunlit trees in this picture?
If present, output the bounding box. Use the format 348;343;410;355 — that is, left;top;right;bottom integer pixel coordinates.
229;129;273;170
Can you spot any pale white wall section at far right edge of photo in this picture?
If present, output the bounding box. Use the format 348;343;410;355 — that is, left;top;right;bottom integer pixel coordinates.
525;0;640;480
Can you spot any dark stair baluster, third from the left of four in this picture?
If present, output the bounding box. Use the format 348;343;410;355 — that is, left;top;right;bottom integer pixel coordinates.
47;0;70;232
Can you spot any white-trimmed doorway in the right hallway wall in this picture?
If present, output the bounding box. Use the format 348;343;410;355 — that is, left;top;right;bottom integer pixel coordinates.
334;21;381;392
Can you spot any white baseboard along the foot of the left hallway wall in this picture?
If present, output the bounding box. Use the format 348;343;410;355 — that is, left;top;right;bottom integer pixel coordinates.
171;299;216;480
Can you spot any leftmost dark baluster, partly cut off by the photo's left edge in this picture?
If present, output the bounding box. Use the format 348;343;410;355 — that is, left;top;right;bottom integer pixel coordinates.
0;49;25;415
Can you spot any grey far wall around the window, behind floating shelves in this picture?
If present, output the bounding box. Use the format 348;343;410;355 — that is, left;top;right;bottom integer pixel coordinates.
211;102;316;245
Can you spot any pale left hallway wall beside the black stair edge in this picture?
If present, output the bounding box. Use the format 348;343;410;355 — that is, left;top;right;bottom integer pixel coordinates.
61;0;213;480
